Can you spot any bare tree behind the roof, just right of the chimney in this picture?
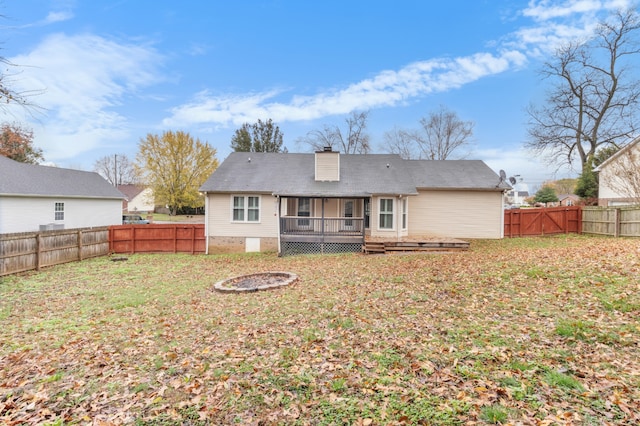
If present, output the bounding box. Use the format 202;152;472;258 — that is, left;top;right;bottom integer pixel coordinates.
297;111;371;154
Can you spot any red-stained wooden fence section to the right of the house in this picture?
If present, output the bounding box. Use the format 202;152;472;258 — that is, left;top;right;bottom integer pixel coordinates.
504;206;582;237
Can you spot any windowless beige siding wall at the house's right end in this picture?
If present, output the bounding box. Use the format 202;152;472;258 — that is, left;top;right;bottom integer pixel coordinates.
408;191;504;238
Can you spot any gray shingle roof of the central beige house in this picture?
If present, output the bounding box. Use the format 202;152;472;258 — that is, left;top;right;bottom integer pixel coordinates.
200;152;509;197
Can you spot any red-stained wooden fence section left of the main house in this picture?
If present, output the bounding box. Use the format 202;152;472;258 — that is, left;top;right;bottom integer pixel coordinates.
109;223;205;254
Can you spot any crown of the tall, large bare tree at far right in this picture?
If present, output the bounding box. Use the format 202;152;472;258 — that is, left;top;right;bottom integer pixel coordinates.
526;9;640;170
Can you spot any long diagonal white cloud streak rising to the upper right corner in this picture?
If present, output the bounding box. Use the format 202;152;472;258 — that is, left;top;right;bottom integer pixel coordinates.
163;0;629;130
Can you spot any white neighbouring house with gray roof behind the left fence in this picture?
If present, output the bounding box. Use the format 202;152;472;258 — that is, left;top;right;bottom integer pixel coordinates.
0;156;124;234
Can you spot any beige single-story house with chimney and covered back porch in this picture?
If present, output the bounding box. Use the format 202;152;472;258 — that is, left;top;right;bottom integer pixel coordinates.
200;148;510;255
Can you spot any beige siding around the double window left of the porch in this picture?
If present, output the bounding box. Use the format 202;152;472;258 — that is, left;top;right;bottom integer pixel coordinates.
207;194;278;238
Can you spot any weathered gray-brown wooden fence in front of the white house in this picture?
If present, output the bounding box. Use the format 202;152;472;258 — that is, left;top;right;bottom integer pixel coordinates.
0;227;109;276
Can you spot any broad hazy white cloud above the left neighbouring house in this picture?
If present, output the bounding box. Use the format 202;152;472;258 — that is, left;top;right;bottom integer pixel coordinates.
10;34;162;161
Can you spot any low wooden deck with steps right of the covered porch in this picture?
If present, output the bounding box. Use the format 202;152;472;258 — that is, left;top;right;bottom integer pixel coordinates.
362;237;469;254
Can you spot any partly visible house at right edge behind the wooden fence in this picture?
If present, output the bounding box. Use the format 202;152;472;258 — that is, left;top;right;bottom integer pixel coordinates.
595;136;640;206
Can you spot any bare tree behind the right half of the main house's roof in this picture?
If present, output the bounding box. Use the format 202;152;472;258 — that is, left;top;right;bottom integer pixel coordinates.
384;106;473;160
